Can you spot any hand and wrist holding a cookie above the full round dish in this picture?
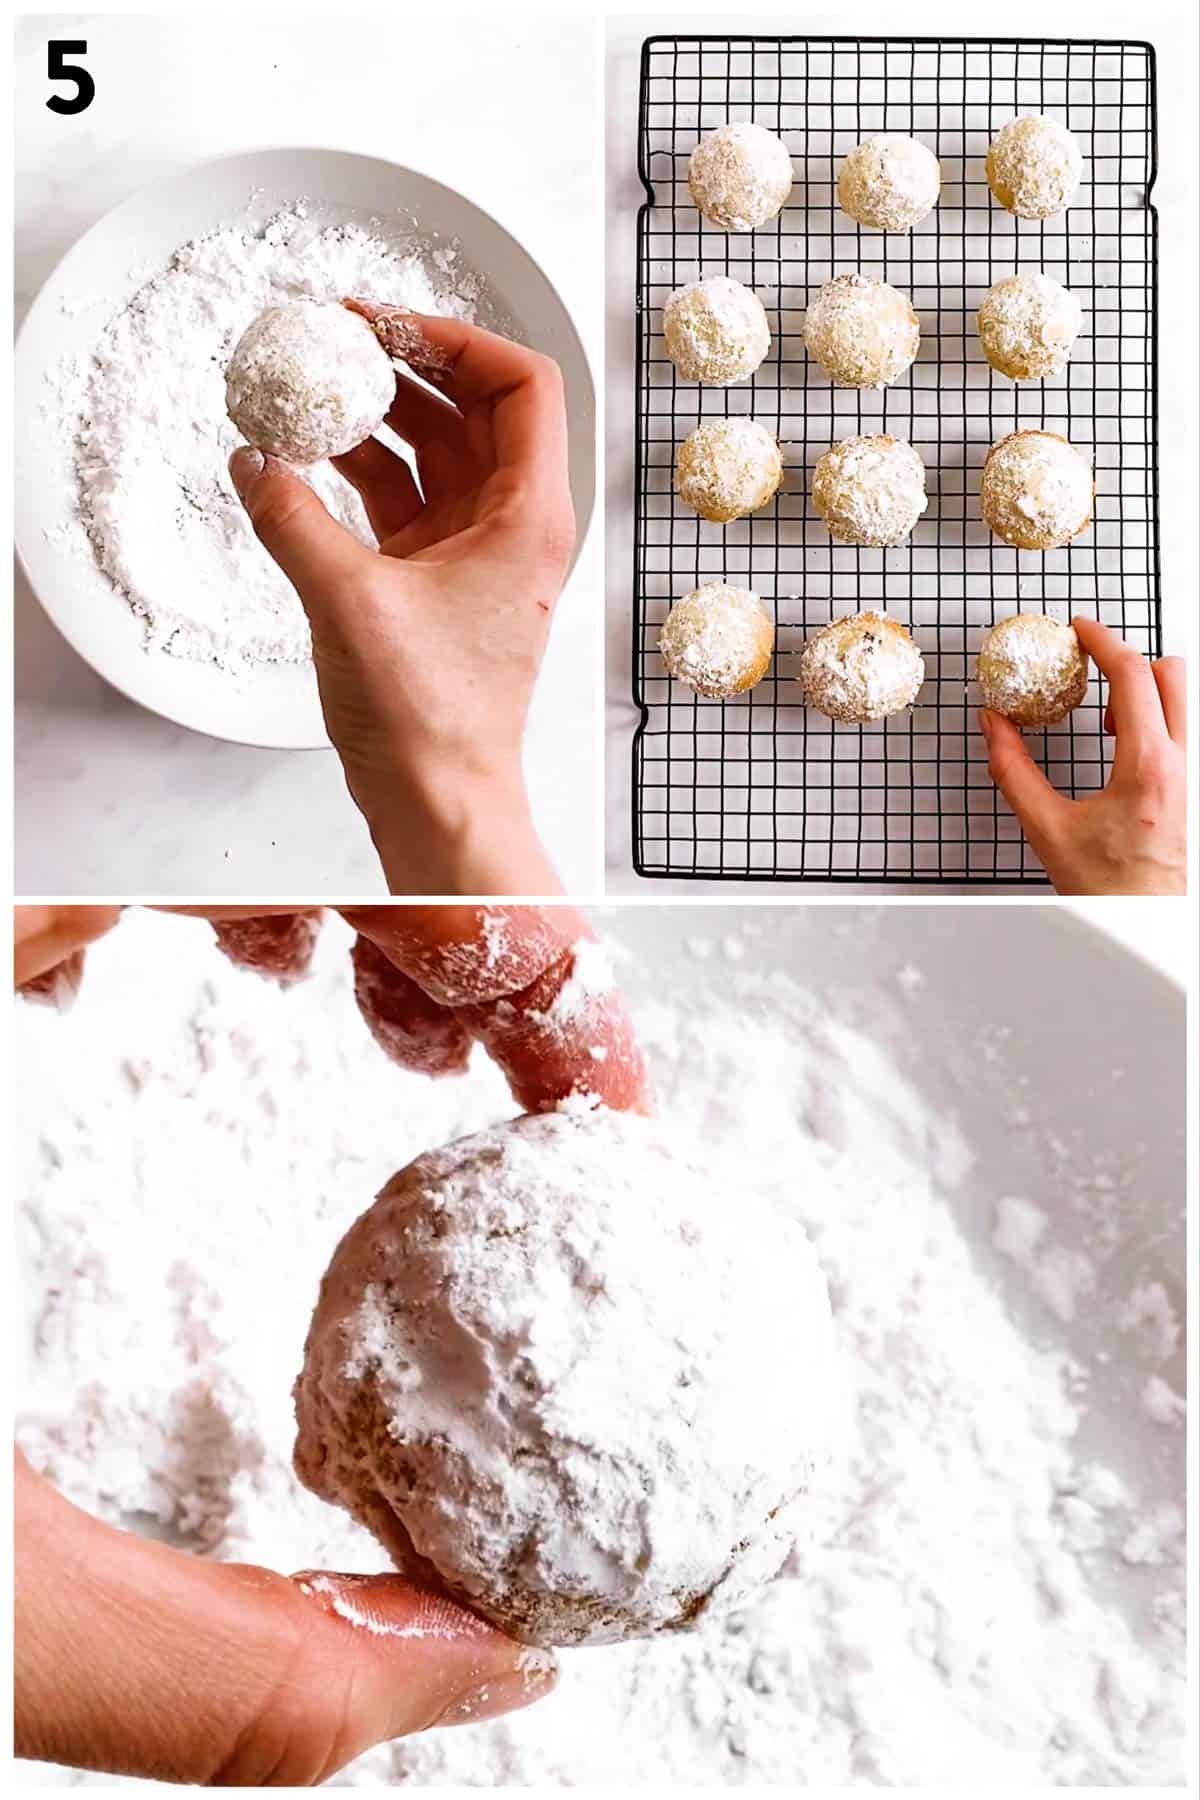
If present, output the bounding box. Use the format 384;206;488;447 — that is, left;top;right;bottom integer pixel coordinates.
230;313;574;895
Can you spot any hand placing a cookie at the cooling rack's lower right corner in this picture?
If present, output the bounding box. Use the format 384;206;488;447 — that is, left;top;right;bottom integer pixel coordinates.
979;619;1187;895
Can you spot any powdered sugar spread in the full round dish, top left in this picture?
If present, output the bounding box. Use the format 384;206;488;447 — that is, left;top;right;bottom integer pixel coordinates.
47;200;479;675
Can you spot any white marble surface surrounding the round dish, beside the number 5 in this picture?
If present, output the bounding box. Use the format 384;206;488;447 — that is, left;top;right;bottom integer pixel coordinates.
14;13;601;898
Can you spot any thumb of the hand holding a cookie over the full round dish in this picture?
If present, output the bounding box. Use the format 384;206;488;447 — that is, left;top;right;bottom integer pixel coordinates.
228;445;372;610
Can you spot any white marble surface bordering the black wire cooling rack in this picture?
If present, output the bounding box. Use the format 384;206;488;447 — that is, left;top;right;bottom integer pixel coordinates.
604;0;1200;902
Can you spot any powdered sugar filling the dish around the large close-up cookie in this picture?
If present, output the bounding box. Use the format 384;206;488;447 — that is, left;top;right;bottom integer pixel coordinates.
18;916;1184;1787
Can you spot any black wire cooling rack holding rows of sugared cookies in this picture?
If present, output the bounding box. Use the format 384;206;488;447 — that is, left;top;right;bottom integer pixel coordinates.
633;36;1160;884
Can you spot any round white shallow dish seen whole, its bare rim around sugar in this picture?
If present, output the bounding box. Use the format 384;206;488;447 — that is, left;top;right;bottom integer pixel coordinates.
14;149;596;749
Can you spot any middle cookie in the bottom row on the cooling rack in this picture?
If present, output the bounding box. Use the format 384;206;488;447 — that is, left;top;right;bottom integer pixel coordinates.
801;612;925;725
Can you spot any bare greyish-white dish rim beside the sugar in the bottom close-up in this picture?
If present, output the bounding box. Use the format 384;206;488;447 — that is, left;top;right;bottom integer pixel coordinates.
594;902;1187;1605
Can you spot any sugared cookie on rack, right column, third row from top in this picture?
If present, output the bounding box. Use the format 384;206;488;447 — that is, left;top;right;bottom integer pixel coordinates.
979;432;1096;551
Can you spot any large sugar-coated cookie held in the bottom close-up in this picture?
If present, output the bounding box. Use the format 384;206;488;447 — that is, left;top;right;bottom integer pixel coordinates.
295;1111;833;1645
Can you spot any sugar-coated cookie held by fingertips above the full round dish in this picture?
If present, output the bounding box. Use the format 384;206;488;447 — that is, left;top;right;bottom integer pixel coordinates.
225;301;396;464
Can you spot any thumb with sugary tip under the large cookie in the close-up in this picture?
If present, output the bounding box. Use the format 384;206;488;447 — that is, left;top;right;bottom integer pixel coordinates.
14;1458;556;1787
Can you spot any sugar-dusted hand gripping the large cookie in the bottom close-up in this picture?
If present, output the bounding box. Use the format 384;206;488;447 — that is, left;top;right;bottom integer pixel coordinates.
14;905;658;1786
